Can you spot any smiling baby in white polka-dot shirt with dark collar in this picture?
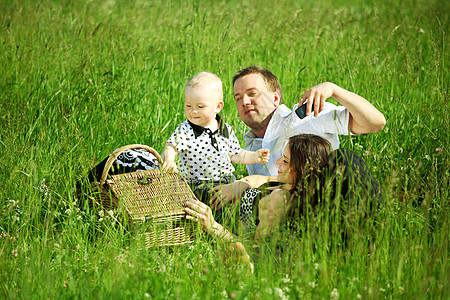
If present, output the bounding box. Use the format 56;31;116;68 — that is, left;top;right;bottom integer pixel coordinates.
162;72;270;206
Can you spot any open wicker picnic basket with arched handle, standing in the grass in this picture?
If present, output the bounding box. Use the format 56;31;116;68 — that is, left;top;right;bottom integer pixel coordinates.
95;144;195;248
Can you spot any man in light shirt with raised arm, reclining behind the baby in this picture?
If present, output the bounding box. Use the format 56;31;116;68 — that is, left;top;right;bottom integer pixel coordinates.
211;66;386;209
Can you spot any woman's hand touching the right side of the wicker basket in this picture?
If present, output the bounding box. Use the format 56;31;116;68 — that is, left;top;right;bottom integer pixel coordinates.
184;199;220;236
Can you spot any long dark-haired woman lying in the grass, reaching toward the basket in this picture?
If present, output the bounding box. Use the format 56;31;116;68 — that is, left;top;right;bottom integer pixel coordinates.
185;134;381;268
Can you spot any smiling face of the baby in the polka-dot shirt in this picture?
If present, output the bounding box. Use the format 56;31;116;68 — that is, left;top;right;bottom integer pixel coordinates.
184;86;223;127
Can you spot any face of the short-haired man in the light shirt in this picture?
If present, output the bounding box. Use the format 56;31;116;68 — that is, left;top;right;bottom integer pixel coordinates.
233;74;280;129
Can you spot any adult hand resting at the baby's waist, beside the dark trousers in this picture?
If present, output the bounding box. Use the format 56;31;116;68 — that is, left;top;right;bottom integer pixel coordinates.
209;180;250;210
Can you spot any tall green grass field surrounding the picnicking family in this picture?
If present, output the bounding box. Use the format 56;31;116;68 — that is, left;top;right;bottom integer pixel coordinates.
0;0;450;299
